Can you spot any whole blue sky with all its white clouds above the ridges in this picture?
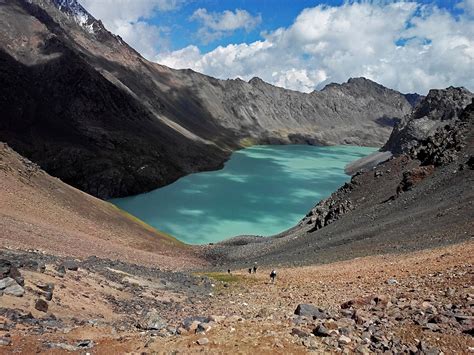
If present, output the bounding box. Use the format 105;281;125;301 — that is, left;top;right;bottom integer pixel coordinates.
79;0;474;94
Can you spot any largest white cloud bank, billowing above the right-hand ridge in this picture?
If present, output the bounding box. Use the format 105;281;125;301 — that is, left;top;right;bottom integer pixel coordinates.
155;0;474;94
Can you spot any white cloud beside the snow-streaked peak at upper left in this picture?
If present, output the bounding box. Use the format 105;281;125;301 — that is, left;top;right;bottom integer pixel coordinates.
79;0;185;59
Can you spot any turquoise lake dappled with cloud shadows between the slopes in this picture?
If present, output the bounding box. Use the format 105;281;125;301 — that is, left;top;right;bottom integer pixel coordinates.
110;145;377;244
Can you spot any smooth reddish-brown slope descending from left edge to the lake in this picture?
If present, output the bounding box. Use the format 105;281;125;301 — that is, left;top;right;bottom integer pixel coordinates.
0;143;205;269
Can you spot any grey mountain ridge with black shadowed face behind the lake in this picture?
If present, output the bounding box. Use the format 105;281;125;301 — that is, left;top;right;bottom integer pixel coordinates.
0;0;412;198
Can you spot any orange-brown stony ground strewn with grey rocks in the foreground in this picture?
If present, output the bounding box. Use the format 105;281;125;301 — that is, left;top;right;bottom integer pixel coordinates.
0;242;474;354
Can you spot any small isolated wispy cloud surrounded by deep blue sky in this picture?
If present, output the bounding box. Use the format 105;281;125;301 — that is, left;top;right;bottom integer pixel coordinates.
190;8;262;43
